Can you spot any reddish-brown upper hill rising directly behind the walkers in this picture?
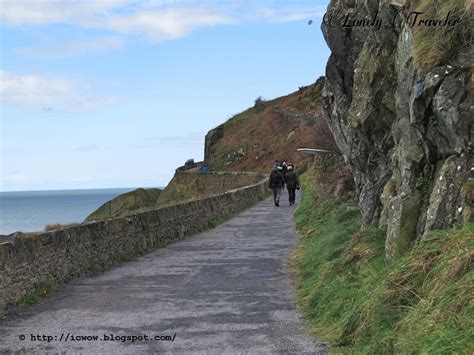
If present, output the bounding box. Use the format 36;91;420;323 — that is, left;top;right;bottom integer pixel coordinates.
204;78;324;172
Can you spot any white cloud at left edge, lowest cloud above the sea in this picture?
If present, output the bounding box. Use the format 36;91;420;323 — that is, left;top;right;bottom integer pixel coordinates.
0;70;114;111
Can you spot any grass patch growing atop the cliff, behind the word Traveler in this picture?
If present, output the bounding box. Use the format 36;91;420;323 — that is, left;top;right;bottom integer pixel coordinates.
413;0;473;69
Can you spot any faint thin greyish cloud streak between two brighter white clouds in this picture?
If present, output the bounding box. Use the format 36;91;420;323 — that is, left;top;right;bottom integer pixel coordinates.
16;36;124;59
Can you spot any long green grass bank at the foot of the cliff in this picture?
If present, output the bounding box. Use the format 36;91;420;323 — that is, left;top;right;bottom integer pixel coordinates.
292;172;474;354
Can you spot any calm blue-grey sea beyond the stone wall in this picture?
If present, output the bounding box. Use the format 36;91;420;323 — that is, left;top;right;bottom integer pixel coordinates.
0;187;135;237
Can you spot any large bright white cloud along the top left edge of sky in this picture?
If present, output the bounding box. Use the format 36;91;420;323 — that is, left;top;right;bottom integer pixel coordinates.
0;0;234;41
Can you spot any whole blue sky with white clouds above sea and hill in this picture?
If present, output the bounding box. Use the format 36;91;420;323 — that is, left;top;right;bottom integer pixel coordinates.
0;0;329;191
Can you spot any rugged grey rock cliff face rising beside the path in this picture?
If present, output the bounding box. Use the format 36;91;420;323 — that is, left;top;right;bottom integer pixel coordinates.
322;0;474;257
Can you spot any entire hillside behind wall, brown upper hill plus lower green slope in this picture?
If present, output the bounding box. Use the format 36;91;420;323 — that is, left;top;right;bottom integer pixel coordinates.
86;78;346;221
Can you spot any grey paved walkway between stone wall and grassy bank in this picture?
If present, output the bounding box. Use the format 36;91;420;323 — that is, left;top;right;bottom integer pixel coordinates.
0;191;326;354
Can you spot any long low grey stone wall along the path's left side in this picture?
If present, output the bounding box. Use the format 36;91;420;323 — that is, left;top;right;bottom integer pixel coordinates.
0;179;268;309
